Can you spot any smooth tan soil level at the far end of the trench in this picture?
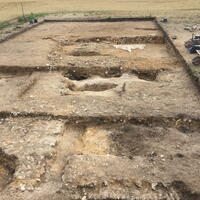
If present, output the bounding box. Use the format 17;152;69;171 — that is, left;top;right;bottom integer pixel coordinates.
0;22;160;67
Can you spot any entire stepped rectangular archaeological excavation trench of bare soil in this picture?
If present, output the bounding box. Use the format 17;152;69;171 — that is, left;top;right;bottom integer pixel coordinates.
0;19;200;200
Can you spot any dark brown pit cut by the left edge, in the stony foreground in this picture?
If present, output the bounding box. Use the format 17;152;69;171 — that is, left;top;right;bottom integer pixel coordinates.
0;149;17;191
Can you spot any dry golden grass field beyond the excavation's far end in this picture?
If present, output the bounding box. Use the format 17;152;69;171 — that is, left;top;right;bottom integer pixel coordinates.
0;0;200;22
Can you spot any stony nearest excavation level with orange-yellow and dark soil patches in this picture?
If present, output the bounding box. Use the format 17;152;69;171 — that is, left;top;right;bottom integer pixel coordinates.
0;118;200;200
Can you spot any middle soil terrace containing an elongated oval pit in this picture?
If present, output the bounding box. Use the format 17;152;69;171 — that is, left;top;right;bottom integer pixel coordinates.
0;68;200;118
